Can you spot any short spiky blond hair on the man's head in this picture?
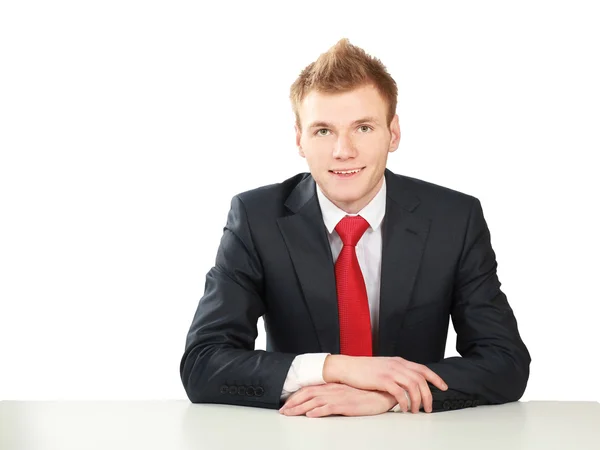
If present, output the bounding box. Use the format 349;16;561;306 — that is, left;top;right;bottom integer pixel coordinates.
290;38;398;128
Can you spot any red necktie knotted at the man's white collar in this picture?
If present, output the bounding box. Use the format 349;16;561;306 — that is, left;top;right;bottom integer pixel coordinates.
335;216;373;356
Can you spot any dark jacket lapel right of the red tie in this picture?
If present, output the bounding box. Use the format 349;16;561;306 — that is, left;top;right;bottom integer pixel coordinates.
377;170;430;356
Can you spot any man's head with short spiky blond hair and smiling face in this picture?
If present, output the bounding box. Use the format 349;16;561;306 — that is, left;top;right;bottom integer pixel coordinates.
290;39;400;213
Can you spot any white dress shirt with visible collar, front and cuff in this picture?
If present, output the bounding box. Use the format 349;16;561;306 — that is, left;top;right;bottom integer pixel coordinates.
281;178;394;400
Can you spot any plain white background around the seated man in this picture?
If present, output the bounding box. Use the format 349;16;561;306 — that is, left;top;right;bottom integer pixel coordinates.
0;0;600;400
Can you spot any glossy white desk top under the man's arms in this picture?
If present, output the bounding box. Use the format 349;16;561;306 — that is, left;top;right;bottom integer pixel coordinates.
0;400;600;450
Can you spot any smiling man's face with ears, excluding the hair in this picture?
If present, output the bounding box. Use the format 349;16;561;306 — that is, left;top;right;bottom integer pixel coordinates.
296;85;400;214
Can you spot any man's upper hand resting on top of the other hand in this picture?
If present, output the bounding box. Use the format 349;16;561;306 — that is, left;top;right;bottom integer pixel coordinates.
323;355;448;413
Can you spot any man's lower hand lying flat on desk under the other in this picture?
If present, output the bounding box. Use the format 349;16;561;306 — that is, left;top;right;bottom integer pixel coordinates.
279;383;396;417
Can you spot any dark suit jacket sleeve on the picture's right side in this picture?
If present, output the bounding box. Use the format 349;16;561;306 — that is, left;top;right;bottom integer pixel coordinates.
426;198;531;411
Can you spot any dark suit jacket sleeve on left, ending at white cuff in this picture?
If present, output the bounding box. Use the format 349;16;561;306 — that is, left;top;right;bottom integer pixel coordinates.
180;196;296;408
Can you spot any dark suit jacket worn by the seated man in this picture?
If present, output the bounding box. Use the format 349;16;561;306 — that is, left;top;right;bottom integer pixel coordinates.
180;170;531;412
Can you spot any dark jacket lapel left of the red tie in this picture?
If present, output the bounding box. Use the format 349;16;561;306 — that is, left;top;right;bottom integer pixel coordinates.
277;176;340;354
